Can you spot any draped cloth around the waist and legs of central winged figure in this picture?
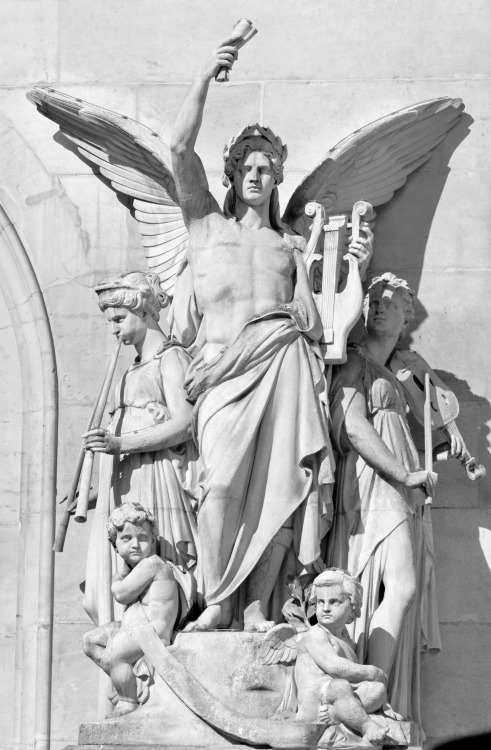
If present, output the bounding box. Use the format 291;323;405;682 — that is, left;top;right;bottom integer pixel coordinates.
171;237;333;605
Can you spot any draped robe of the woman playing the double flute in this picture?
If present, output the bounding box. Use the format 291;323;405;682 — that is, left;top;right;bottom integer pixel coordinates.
84;344;198;625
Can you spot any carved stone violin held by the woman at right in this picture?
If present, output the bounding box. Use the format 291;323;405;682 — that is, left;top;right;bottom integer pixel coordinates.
390;349;486;481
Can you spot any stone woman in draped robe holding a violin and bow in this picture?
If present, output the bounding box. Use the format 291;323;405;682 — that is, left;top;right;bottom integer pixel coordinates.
329;273;462;736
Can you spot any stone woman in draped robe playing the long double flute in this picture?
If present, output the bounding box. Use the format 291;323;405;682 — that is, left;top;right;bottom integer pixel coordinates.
84;272;198;625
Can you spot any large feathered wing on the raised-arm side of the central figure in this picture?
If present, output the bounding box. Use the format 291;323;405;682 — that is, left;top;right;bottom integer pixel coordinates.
27;86;188;296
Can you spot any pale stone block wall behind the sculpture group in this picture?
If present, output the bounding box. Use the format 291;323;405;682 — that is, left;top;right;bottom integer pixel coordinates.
0;0;491;750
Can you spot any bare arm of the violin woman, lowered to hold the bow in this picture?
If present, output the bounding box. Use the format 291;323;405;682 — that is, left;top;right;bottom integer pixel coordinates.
344;390;436;500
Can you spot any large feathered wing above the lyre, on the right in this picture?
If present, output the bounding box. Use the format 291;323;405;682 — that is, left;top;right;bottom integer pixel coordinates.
283;97;464;236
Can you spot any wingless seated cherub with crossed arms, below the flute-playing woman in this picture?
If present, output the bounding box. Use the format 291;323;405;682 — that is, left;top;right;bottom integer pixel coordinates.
83;503;179;716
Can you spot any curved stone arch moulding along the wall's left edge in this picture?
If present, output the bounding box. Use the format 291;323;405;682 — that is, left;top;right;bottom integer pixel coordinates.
0;115;87;750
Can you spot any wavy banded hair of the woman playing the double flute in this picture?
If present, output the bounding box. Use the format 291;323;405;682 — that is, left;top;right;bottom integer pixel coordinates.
95;271;169;322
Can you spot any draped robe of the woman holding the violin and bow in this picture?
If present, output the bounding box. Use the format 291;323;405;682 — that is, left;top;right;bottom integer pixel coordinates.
328;347;441;736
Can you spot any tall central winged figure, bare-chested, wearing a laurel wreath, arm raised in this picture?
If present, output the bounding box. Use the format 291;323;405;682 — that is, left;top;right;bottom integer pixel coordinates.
28;47;463;631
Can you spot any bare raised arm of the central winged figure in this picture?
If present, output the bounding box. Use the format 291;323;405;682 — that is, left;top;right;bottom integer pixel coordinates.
170;38;237;218
